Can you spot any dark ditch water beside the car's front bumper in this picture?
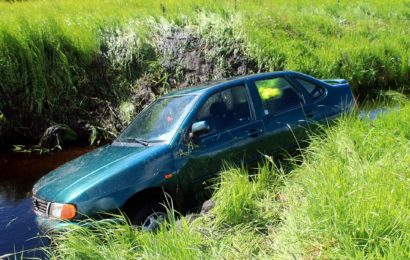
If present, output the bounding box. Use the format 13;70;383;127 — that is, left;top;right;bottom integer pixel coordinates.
0;147;92;259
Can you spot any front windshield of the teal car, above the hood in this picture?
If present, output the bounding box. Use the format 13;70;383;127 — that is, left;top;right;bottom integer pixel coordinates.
116;95;195;145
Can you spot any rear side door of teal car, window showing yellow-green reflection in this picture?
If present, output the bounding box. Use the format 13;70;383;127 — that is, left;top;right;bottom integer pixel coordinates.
245;76;317;154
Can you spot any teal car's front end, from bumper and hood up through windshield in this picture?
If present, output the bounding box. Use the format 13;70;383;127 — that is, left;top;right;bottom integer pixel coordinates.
33;95;199;230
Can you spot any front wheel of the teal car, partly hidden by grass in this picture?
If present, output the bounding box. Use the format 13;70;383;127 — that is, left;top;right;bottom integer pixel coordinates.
127;200;167;231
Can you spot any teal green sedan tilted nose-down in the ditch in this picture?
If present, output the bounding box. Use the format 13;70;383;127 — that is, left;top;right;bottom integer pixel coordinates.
33;71;354;230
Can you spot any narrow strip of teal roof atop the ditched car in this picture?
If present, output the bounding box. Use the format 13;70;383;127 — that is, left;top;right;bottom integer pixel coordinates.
163;71;297;97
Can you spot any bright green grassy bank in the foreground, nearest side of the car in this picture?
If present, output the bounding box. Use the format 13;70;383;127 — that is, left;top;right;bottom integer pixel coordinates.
43;101;410;259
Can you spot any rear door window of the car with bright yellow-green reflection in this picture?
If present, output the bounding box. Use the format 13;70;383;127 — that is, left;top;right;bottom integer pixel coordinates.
255;77;303;115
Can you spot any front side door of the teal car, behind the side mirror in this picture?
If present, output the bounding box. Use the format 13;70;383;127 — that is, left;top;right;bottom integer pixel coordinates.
176;84;264;205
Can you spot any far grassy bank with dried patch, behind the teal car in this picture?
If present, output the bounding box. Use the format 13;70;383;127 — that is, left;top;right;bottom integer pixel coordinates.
0;0;410;146
